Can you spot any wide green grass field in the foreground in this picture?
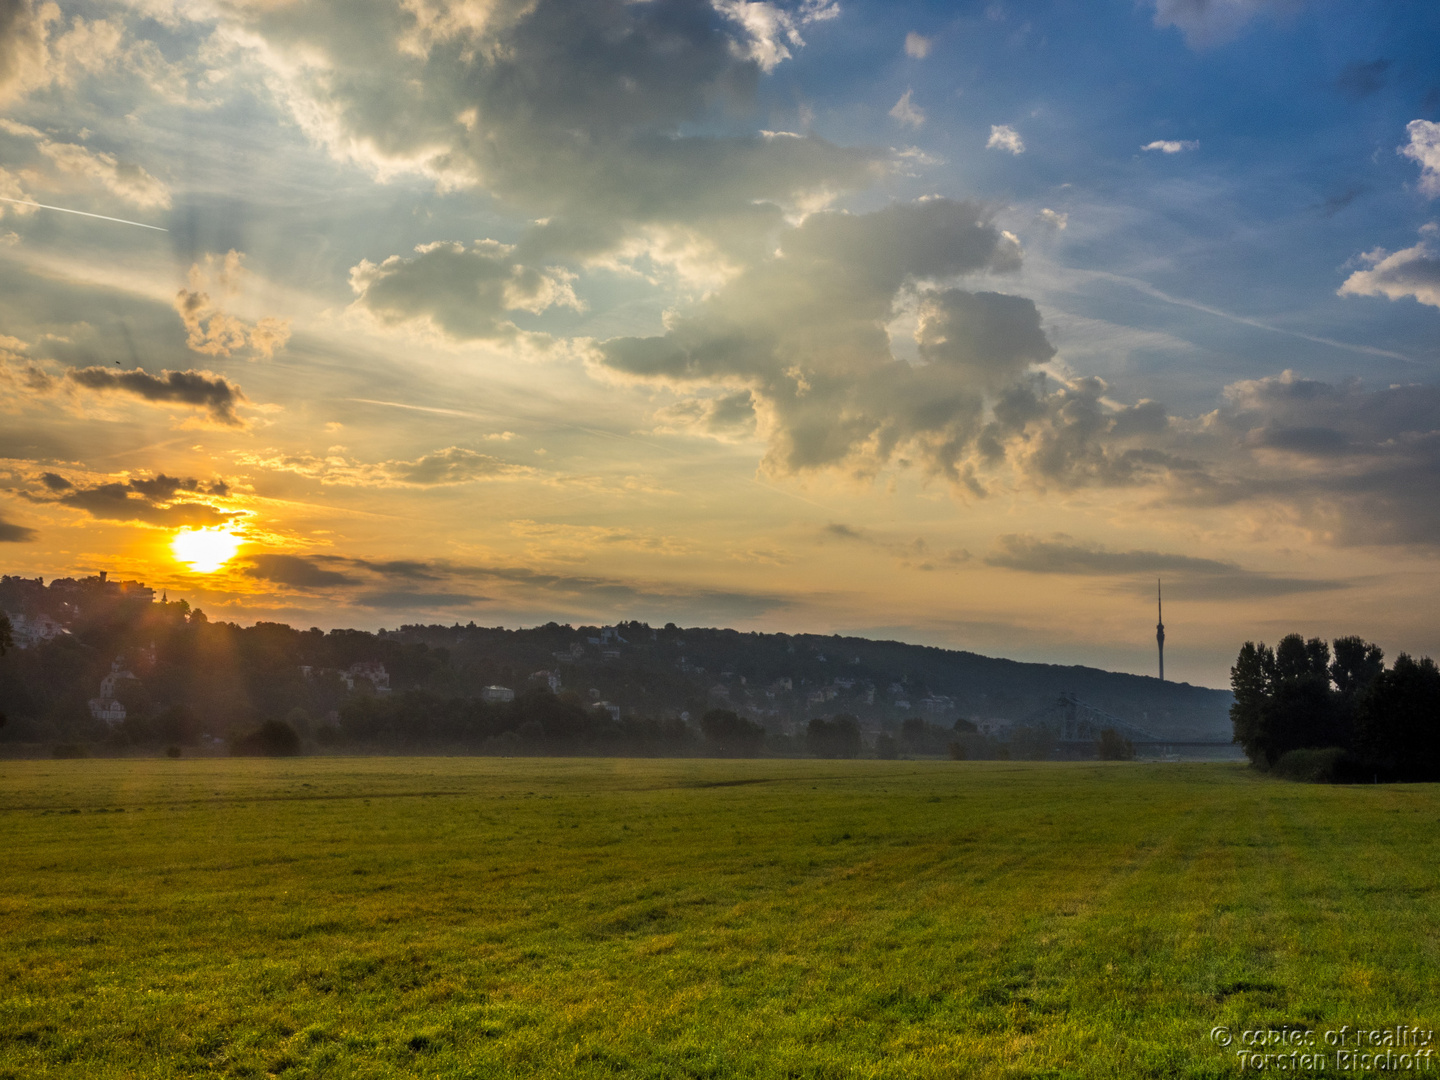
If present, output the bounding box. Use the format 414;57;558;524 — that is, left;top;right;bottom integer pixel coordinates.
0;757;1440;1077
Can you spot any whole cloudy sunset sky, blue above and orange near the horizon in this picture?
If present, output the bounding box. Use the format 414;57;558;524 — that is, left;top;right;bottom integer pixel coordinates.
0;0;1440;685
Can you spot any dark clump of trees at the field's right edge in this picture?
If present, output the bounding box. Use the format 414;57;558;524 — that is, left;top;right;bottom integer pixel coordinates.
1230;634;1440;782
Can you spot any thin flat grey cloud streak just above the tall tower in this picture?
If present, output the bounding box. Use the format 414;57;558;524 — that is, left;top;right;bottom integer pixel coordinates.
985;533;1348;599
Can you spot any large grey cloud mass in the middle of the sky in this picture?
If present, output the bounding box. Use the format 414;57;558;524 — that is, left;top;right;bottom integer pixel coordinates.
595;199;1054;475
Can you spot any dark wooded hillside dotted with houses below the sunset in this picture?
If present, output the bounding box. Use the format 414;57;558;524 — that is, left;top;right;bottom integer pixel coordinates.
0;577;1231;744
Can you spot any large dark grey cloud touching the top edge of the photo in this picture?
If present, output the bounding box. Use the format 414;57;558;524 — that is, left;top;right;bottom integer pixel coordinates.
220;0;886;270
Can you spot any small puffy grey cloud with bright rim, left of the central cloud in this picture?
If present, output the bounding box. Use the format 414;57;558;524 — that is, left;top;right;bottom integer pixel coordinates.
350;240;582;341
